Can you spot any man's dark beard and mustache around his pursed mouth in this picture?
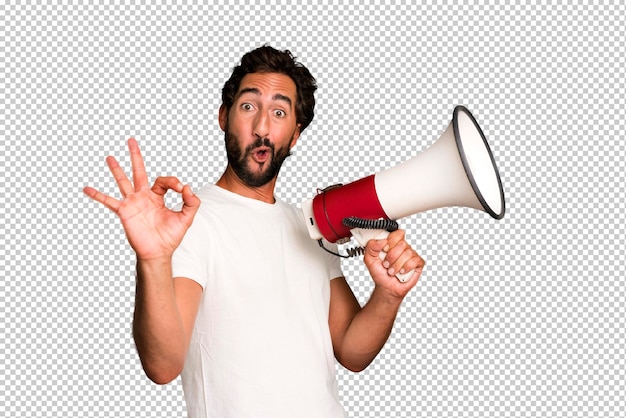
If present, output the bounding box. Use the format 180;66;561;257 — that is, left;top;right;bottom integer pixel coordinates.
225;127;291;187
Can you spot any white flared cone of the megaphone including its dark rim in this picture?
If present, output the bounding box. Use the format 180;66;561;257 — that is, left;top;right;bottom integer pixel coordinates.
375;106;504;219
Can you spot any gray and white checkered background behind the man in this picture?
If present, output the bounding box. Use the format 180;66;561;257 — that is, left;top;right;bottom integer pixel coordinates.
0;0;626;417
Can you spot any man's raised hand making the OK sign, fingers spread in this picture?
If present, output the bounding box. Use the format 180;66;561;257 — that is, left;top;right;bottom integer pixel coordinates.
84;138;200;261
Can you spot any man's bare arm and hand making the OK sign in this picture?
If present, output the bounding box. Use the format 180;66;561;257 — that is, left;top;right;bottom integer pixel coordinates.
84;139;202;383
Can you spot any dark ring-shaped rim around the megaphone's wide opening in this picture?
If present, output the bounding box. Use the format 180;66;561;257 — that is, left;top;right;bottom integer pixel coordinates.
452;106;505;219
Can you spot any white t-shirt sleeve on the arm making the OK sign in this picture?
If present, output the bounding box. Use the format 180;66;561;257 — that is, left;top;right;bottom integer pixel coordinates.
172;213;209;289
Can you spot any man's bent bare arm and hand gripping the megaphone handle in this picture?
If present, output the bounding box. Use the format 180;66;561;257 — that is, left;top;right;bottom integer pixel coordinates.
329;231;424;372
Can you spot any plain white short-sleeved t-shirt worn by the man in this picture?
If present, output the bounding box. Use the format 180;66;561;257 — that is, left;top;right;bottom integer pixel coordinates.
172;184;346;418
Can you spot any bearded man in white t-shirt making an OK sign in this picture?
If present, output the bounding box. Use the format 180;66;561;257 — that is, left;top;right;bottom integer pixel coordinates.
85;46;424;418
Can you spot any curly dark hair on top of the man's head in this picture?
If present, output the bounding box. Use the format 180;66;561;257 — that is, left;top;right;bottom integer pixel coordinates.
222;45;317;132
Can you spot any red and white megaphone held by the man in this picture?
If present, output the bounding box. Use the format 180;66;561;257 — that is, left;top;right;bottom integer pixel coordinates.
302;106;505;280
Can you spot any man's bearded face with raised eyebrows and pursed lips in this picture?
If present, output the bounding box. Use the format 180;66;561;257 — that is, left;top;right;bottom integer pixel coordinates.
219;73;300;187
